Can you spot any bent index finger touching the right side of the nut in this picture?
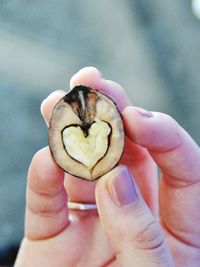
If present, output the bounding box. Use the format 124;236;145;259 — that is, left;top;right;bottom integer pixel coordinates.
123;107;200;249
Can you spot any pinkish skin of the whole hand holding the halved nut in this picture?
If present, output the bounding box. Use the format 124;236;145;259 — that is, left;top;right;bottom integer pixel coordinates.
15;67;200;267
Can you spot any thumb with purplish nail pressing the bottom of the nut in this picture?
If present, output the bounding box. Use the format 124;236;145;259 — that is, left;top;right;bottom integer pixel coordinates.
96;165;174;267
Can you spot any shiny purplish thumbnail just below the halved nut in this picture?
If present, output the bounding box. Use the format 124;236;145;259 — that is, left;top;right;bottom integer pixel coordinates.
108;165;138;207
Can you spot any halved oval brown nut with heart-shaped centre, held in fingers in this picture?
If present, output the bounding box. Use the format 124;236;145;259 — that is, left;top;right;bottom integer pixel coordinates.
49;85;124;181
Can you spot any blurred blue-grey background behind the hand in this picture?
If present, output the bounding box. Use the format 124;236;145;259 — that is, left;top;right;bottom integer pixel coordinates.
0;0;200;266
